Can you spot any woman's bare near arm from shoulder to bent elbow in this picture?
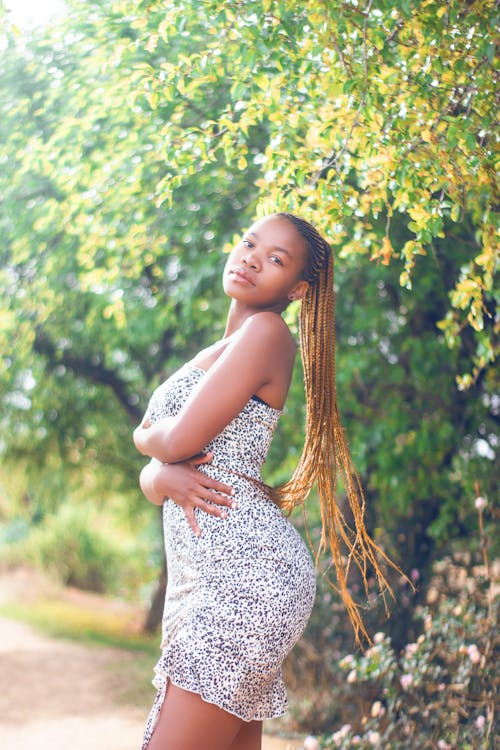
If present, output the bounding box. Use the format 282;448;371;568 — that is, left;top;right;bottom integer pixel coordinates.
134;312;295;464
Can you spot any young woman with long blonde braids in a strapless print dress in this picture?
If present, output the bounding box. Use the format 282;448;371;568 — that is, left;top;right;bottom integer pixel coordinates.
134;214;394;750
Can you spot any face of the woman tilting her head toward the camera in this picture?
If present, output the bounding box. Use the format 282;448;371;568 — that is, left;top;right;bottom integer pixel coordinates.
223;216;308;312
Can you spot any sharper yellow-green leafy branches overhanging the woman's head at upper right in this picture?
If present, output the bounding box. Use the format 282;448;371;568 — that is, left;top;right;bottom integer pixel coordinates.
134;0;496;387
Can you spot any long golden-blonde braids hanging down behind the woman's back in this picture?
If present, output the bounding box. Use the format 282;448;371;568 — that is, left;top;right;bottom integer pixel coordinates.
273;213;399;642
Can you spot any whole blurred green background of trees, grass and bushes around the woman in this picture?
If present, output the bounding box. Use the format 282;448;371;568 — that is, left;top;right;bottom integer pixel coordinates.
0;0;500;750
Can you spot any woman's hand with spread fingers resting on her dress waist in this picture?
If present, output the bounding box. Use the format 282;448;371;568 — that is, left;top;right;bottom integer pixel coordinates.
140;453;237;536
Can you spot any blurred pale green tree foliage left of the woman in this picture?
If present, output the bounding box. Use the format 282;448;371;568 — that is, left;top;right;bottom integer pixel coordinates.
0;3;262;483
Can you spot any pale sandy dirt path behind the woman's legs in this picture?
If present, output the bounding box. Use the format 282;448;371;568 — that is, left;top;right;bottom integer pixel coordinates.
0;617;302;750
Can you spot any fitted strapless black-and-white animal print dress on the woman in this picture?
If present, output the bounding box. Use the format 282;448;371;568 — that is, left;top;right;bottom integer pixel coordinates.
143;364;316;750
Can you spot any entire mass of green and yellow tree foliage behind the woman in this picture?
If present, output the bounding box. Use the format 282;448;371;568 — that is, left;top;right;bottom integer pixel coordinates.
0;0;498;630
